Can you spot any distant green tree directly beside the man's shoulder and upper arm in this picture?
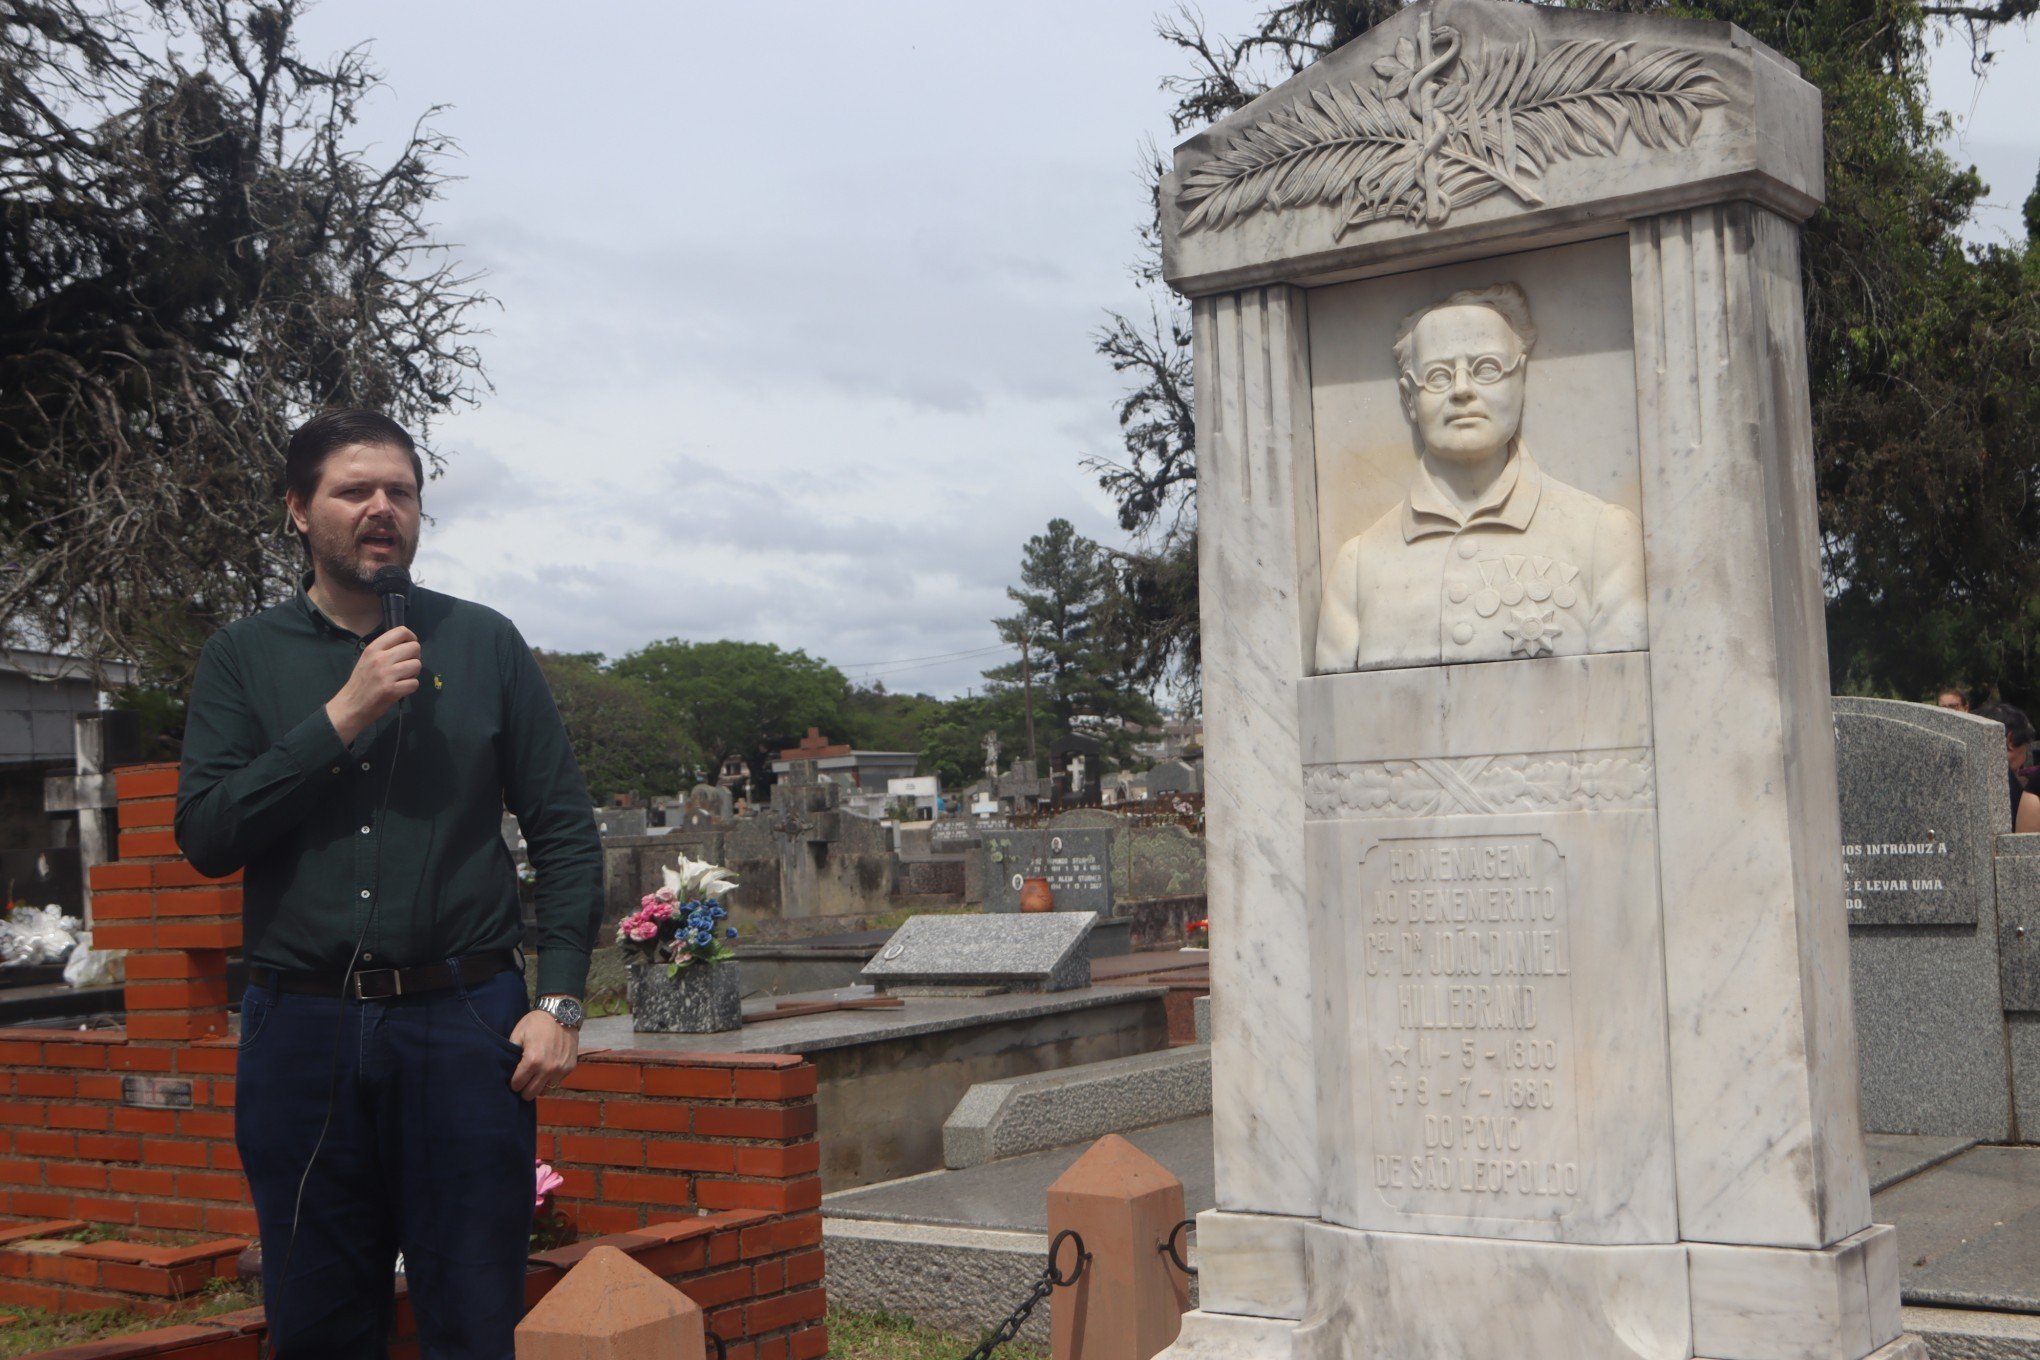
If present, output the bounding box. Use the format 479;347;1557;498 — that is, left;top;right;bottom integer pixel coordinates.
532;648;702;803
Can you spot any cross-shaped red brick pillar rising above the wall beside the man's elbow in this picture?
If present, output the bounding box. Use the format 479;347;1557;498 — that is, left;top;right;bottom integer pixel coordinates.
92;765;241;1040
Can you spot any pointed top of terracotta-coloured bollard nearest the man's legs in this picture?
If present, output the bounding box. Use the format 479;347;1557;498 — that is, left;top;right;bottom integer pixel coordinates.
516;1246;706;1360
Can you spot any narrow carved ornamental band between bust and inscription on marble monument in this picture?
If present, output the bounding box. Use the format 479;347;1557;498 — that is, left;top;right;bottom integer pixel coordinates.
1304;748;1656;822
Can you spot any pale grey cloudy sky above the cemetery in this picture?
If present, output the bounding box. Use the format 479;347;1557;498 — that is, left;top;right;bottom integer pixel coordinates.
287;0;2040;695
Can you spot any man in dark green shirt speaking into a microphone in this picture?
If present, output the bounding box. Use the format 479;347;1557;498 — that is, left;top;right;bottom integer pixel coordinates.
177;412;602;1360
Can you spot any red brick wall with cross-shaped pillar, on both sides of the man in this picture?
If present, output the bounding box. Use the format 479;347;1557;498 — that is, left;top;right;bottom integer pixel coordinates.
0;765;822;1360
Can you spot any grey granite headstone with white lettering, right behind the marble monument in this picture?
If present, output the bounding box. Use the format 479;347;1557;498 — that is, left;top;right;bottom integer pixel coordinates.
1834;697;2011;1140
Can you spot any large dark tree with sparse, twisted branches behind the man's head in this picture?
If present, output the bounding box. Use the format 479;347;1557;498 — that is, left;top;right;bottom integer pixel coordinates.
0;0;486;687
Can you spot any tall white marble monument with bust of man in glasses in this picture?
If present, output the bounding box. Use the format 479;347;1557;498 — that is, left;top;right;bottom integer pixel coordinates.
1163;0;1926;1360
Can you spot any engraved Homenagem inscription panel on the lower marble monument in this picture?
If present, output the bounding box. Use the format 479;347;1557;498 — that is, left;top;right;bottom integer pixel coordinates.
1357;836;1585;1219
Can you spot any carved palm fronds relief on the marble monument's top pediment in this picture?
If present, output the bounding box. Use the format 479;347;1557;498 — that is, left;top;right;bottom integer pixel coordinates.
1177;22;1728;237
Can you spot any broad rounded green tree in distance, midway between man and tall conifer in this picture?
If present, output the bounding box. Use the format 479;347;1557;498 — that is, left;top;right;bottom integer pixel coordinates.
610;638;849;797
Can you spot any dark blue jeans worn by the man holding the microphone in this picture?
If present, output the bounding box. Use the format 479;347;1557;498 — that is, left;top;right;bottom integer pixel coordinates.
235;971;539;1360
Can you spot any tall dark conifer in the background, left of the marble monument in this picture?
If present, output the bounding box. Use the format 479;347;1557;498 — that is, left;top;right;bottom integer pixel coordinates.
985;520;1155;762
